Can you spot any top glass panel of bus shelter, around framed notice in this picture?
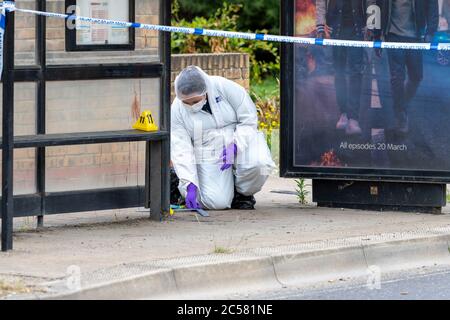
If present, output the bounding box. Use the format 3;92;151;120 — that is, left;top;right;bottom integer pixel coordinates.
46;0;160;65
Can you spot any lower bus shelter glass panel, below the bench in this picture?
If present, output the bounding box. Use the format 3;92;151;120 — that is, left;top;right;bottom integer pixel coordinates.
46;142;145;192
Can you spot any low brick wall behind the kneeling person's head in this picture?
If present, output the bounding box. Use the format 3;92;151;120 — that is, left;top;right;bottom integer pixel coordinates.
171;53;250;100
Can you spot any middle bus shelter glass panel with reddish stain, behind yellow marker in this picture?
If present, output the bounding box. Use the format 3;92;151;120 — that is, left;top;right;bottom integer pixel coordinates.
46;78;160;133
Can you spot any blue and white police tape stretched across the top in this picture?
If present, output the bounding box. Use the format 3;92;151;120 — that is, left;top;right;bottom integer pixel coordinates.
0;1;450;51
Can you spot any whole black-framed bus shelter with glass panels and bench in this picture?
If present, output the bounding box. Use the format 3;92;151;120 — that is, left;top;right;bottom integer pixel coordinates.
0;0;171;251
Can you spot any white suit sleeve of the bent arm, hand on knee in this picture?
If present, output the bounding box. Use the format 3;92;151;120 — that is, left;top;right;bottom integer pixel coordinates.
222;79;258;151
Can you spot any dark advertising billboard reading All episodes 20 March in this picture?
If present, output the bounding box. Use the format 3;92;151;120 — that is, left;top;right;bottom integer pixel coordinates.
282;0;450;182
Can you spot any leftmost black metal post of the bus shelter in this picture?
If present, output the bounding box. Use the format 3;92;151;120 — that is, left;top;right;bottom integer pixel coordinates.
2;1;14;251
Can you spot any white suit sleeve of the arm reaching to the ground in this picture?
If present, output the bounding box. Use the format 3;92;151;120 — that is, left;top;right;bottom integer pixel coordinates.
170;106;199;193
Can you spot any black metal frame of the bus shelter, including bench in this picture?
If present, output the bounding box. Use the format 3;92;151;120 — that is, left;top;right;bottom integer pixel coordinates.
0;0;171;251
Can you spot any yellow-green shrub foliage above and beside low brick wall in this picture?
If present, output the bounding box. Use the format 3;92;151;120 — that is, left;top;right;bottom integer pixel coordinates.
172;0;280;82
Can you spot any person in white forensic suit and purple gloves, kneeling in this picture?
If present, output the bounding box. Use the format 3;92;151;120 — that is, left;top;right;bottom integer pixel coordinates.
171;66;275;210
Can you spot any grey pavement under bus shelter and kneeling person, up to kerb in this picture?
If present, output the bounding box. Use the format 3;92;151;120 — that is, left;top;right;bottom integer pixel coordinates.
0;177;450;298
